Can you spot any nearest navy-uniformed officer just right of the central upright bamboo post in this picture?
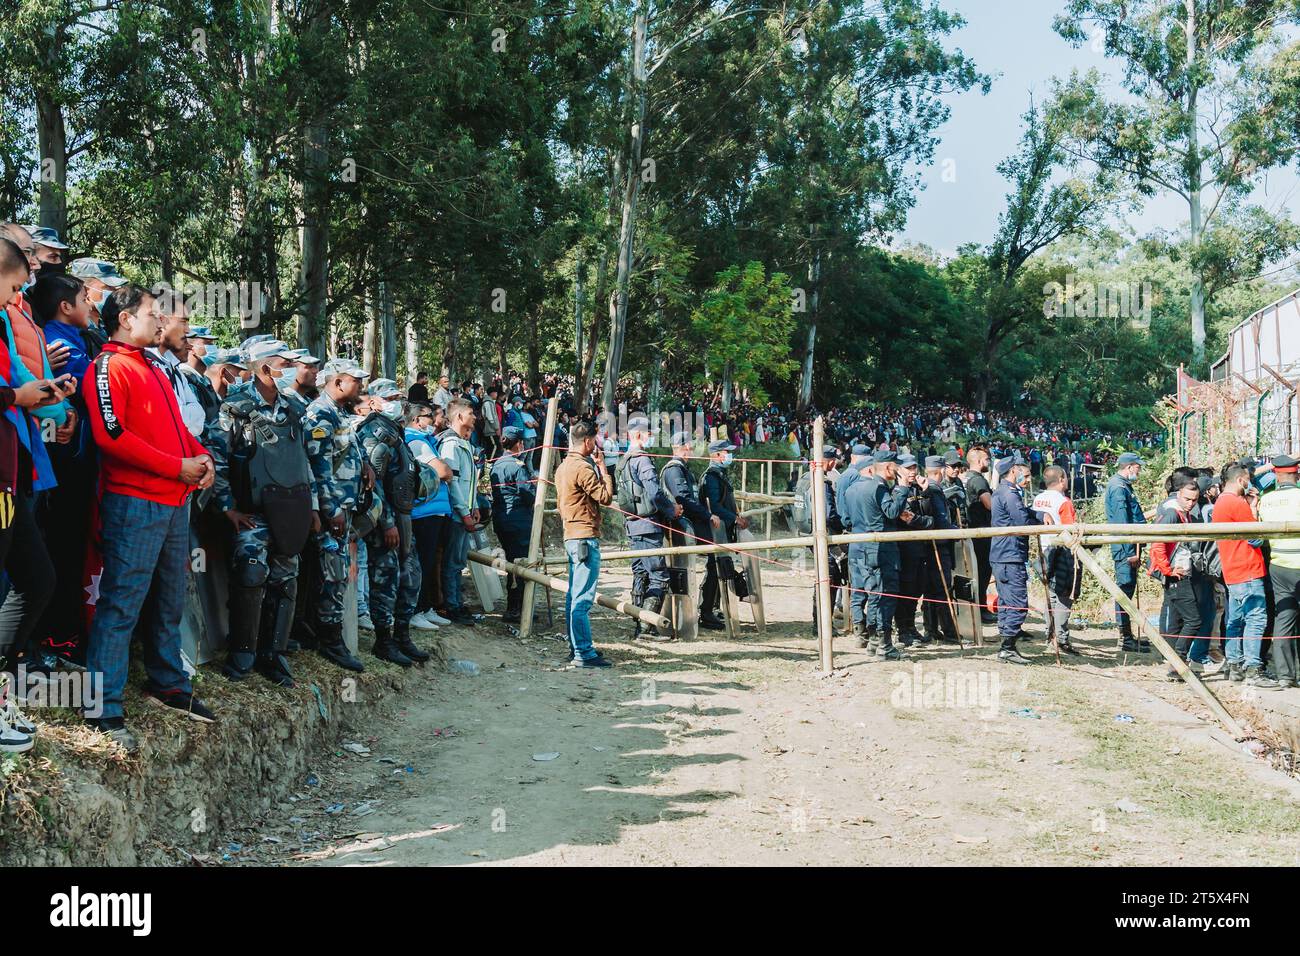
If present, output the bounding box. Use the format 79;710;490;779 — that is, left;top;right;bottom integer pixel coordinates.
848;450;911;661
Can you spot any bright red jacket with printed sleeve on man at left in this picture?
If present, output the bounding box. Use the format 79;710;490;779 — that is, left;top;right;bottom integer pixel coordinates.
82;342;208;505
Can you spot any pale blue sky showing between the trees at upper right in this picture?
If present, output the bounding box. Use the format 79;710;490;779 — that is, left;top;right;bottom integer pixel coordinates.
894;0;1300;255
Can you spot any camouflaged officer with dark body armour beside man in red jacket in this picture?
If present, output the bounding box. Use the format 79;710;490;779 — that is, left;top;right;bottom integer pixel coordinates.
211;339;320;687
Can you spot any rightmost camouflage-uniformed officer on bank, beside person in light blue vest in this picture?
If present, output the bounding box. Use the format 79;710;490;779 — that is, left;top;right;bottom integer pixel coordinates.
358;378;429;667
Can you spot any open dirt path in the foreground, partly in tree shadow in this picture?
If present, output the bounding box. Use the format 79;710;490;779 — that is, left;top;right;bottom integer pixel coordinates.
239;576;1300;866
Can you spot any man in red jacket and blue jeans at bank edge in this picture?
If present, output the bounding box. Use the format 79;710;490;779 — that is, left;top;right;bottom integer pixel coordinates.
82;285;216;750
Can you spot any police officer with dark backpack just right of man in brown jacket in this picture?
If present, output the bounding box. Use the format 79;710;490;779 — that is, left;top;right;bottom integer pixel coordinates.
615;416;681;641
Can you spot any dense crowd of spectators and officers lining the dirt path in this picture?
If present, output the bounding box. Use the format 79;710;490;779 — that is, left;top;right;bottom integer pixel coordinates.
0;224;1268;752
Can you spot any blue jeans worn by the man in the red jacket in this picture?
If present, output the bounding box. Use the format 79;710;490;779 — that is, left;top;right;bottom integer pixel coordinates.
86;493;190;717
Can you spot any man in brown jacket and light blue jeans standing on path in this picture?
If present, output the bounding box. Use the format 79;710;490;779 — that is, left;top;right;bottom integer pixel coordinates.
555;421;614;667
